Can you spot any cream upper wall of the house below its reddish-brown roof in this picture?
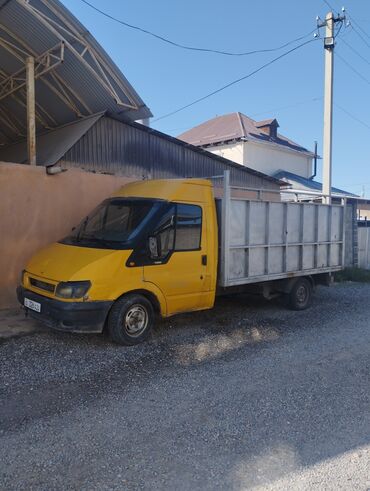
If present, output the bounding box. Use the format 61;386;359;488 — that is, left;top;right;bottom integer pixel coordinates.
207;141;312;177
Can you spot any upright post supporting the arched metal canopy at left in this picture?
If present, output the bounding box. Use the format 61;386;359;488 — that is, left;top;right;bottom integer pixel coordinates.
26;56;36;165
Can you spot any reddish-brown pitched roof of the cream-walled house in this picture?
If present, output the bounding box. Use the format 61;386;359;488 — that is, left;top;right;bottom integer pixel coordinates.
178;112;314;157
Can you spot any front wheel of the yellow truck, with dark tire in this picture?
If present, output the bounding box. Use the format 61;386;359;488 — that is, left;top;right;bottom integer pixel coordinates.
107;294;154;346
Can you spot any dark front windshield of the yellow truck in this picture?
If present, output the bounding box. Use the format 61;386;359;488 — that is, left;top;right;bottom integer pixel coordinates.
61;198;159;247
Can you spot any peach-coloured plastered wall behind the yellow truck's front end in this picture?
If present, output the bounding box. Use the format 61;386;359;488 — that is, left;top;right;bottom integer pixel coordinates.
0;163;130;308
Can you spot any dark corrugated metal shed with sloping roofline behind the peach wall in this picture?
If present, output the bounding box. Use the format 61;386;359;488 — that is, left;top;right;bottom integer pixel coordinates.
0;112;283;193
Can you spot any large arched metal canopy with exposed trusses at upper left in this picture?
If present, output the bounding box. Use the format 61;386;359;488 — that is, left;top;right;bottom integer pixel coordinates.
0;0;152;145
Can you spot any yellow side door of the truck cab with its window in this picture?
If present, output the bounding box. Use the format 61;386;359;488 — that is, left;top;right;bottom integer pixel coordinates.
144;203;209;314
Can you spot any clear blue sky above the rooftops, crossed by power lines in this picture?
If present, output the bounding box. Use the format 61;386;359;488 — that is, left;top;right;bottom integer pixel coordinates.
62;0;370;197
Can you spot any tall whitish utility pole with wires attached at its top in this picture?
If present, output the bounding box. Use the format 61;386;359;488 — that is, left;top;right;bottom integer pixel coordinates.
317;10;345;204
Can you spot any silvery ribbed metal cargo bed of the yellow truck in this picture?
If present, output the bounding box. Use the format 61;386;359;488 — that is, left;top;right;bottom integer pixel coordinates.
217;172;345;287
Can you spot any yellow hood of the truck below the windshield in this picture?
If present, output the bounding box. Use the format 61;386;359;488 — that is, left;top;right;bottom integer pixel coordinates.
26;243;131;281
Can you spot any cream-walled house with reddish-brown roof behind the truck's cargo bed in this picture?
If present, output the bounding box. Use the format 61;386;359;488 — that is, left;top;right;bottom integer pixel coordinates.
178;112;315;178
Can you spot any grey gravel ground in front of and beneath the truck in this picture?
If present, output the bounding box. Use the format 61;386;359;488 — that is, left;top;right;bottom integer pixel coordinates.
0;283;370;491
